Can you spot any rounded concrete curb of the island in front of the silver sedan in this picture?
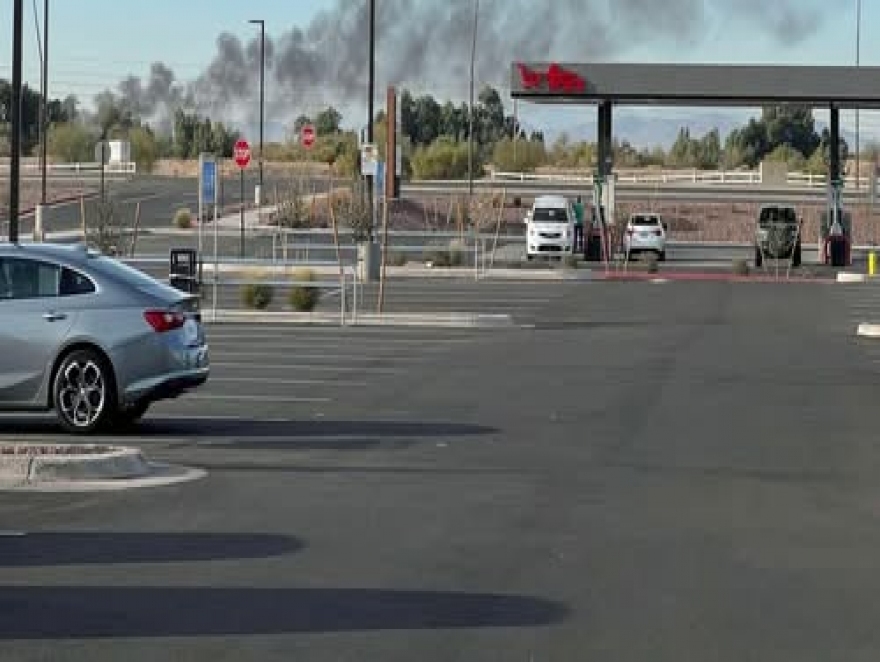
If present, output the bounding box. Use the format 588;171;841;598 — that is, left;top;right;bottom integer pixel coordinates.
0;444;150;483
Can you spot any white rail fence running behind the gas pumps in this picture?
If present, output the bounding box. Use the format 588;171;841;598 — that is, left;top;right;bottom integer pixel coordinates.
490;169;871;189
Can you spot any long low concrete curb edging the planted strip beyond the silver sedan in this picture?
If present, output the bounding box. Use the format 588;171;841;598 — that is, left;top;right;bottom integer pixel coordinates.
203;310;516;329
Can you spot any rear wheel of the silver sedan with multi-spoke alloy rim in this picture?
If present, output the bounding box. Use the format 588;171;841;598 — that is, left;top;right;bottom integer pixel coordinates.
53;349;116;434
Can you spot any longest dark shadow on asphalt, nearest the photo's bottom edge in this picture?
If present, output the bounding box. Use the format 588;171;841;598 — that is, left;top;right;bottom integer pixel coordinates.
0;586;568;640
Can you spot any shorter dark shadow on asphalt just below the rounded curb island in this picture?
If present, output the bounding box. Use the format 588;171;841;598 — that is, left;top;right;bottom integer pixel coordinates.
0;531;304;568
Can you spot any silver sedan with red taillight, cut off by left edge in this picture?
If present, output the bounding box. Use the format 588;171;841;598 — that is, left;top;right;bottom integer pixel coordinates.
0;243;210;433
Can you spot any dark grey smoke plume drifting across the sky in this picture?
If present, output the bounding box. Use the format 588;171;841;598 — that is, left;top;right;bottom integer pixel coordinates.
101;0;821;135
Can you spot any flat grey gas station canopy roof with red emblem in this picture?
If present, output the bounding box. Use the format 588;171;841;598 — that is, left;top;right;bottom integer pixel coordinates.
510;62;880;109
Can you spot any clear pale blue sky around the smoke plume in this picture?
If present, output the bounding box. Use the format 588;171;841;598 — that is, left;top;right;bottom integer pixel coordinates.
0;0;880;148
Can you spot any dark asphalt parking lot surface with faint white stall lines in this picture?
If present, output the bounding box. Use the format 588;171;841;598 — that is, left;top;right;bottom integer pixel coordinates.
8;282;880;662
